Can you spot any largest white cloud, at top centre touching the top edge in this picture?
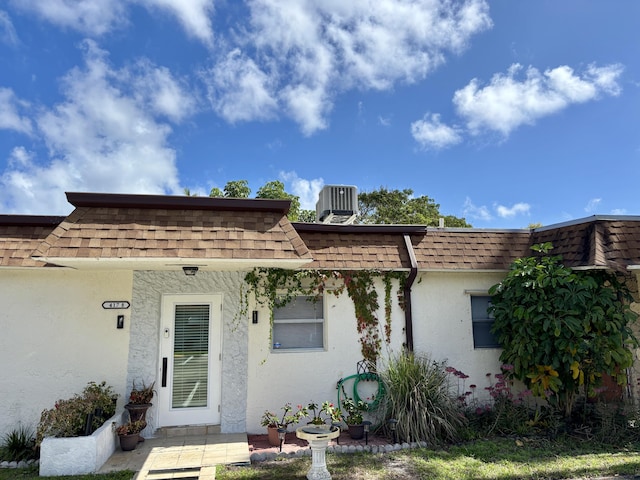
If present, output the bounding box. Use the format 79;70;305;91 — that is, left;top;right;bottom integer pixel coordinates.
209;0;491;135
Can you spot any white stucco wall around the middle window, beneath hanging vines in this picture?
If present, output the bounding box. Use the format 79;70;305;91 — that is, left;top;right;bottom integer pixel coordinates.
247;281;404;433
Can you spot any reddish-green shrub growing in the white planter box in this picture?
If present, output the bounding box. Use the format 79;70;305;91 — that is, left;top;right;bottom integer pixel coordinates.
36;382;117;446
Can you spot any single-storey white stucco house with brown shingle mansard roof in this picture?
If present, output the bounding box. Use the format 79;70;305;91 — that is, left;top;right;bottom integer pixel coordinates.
0;193;640;442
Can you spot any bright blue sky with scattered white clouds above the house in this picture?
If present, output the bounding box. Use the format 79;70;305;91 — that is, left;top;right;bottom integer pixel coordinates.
0;0;640;228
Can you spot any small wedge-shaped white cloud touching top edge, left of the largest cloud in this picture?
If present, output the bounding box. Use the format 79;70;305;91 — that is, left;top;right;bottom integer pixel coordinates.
139;0;214;45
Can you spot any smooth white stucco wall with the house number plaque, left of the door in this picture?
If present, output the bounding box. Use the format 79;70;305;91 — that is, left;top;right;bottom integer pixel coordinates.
0;268;132;436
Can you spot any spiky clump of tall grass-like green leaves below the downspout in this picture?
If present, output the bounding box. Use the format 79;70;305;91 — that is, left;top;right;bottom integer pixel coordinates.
381;352;465;445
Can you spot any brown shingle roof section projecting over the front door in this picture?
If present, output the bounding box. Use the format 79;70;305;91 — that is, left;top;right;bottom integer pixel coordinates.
33;194;311;264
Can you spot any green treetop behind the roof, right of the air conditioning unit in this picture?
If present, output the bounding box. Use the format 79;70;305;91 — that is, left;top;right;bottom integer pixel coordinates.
357;187;471;227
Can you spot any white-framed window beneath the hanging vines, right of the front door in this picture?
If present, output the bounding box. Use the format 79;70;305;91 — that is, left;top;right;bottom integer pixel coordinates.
273;296;324;350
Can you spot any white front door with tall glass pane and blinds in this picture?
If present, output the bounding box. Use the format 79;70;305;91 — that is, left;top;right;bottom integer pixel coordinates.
156;294;222;426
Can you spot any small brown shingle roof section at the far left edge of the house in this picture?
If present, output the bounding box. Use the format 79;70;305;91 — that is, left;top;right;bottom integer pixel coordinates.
0;215;64;267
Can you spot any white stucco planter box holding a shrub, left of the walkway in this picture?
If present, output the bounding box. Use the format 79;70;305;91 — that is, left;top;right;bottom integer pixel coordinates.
40;412;124;477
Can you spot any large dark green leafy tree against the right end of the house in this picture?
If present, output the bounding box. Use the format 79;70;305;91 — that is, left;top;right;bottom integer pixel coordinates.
489;243;638;416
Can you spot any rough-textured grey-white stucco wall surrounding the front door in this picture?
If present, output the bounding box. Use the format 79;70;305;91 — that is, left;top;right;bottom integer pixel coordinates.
127;271;249;436
